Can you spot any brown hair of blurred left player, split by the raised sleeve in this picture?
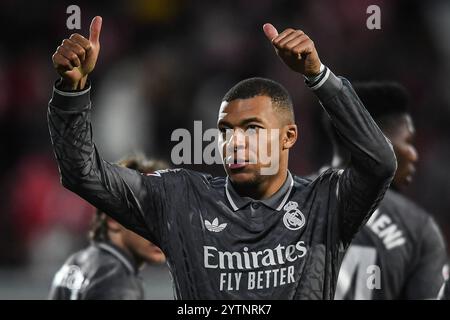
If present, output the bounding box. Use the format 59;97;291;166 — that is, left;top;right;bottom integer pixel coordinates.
89;154;169;242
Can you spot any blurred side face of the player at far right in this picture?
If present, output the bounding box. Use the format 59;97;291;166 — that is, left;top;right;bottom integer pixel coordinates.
386;114;418;188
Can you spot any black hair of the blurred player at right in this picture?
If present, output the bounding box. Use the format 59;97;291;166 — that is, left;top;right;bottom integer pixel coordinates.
353;81;410;129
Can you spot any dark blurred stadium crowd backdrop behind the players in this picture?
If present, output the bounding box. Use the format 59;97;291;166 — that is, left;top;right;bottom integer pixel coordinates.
0;0;450;299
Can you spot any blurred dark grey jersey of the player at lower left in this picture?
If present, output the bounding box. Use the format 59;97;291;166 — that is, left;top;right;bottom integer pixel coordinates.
49;242;144;300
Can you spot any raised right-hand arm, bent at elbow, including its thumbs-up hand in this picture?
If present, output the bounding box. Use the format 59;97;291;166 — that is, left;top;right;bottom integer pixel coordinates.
263;24;397;244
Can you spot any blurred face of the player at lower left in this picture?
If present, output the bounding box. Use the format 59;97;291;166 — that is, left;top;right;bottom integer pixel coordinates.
123;228;166;263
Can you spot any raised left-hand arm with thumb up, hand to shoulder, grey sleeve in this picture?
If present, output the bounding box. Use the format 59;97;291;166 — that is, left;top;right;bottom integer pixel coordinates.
48;17;163;245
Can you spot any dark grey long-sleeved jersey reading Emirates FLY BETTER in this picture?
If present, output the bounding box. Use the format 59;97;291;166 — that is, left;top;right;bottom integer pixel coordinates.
48;70;396;299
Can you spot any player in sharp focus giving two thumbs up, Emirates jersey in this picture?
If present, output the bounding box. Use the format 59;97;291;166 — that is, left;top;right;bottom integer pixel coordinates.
48;17;396;299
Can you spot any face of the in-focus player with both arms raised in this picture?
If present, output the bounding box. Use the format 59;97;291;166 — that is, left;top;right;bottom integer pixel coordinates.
218;96;283;185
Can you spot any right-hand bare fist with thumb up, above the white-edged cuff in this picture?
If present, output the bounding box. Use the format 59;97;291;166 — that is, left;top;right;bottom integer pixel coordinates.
263;23;321;77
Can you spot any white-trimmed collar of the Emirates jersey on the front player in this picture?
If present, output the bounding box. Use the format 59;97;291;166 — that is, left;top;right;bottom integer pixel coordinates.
225;171;294;211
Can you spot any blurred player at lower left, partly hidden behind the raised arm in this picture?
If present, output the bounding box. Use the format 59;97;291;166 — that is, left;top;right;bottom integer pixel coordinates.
49;157;167;300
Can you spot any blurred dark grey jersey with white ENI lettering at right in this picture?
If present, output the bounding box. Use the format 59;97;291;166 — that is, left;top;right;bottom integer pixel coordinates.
336;190;447;300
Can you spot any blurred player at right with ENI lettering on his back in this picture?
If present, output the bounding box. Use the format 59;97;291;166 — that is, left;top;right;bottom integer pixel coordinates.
325;82;446;300
